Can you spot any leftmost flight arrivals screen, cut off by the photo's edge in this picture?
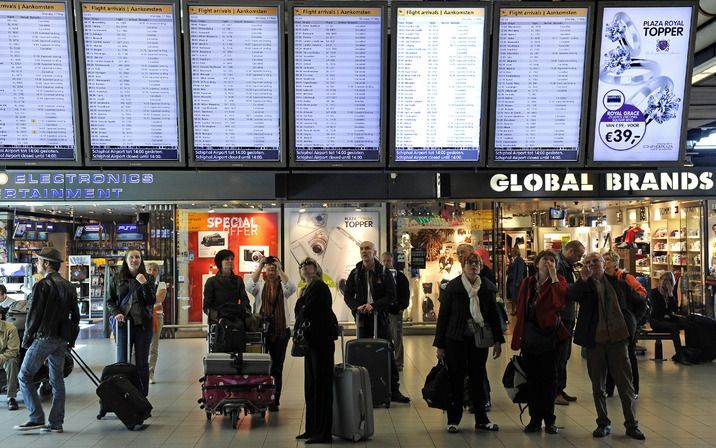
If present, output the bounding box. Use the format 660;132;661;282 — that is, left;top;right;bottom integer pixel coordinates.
0;1;78;163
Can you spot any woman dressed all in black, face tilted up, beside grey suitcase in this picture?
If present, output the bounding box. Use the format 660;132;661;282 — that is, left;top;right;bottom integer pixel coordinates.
295;258;338;444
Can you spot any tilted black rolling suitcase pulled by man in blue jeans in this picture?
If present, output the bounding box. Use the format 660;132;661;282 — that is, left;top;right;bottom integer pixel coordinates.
70;349;152;431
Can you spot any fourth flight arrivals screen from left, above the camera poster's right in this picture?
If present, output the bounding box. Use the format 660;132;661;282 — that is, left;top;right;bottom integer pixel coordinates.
293;7;383;162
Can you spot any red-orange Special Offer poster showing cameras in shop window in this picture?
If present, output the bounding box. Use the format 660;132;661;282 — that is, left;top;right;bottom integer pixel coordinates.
188;212;279;323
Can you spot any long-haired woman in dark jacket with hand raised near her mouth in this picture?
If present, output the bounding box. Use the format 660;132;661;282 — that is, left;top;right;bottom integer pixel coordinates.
107;248;156;396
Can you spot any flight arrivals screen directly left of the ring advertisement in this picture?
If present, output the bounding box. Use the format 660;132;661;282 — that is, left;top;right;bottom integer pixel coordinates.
493;7;589;162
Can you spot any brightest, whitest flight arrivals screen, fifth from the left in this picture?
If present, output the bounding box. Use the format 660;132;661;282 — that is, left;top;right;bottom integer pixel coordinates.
393;7;485;162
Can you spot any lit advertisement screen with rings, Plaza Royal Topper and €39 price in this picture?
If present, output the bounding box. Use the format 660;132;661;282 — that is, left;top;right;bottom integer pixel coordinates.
593;6;693;162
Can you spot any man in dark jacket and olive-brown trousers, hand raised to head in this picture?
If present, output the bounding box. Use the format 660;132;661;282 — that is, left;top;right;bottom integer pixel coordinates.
569;252;646;440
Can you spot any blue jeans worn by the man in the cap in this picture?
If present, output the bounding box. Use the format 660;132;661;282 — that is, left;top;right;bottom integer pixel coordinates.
18;337;67;426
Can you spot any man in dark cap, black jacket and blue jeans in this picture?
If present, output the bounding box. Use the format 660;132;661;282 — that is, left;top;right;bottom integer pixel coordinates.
14;247;80;432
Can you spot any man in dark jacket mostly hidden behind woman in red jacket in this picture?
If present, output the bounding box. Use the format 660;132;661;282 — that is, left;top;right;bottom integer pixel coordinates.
554;240;586;405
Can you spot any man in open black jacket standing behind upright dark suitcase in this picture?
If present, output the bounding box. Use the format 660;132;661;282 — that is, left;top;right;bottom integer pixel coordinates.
344;241;410;403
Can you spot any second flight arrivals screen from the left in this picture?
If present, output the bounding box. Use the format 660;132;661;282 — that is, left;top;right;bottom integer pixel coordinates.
82;3;180;161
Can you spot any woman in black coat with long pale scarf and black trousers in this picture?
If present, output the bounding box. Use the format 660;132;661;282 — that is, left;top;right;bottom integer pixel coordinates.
433;254;505;433
